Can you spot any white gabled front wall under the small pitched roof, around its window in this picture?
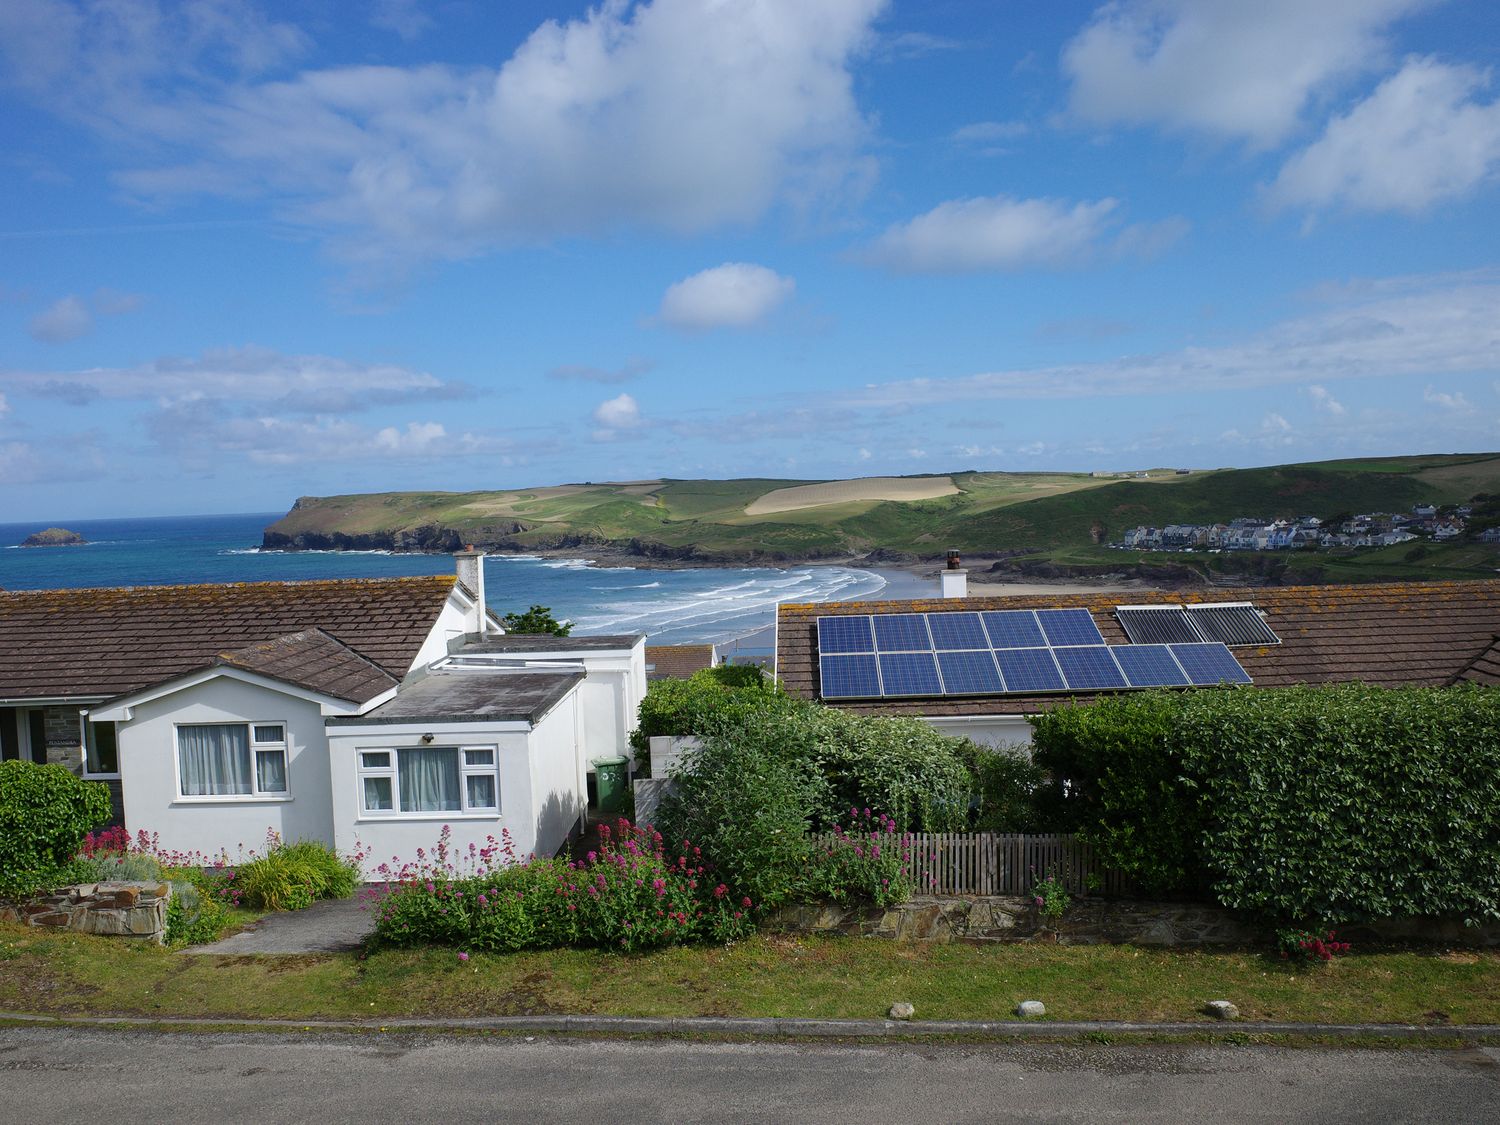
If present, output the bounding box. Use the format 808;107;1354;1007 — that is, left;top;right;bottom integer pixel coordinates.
117;677;333;860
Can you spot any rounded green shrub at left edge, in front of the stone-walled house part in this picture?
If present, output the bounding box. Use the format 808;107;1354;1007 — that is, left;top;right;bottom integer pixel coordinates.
0;762;111;899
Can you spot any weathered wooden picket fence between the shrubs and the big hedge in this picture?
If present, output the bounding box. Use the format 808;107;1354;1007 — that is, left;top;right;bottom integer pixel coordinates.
815;833;1130;896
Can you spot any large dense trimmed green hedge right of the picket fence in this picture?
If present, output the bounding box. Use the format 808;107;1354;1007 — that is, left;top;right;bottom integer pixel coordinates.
1032;684;1500;923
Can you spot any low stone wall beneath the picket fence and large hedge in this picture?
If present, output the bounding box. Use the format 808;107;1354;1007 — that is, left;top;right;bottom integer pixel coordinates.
771;896;1500;948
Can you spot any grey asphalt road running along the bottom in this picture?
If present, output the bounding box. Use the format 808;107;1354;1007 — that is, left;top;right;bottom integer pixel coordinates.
0;1028;1500;1125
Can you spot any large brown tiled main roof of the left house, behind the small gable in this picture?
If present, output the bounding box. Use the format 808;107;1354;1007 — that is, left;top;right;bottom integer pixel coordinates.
0;576;455;699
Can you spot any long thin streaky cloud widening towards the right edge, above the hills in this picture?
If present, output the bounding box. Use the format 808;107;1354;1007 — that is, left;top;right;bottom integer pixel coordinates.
830;273;1500;408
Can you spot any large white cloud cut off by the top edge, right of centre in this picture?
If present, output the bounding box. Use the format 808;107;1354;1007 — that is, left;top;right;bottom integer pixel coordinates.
1062;0;1428;147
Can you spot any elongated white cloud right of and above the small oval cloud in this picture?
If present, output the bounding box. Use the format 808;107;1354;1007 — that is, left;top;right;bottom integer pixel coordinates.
861;195;1187;273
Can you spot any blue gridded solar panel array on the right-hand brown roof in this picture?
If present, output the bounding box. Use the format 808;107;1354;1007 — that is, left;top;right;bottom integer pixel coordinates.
818;609;1250;699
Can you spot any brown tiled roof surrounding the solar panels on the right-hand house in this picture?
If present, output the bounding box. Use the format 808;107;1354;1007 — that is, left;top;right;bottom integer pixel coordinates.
777;581;1500;716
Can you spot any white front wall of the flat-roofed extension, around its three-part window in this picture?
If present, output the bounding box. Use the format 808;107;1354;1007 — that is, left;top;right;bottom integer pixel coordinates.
329;723;557;879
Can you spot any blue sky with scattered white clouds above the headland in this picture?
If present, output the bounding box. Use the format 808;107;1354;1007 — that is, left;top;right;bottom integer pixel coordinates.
0;0;1500;521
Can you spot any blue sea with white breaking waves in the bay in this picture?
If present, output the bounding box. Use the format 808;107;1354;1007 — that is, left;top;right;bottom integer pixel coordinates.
0;512;936;659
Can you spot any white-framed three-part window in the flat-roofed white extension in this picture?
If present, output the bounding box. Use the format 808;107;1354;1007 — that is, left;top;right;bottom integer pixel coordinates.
359;746;500;816
